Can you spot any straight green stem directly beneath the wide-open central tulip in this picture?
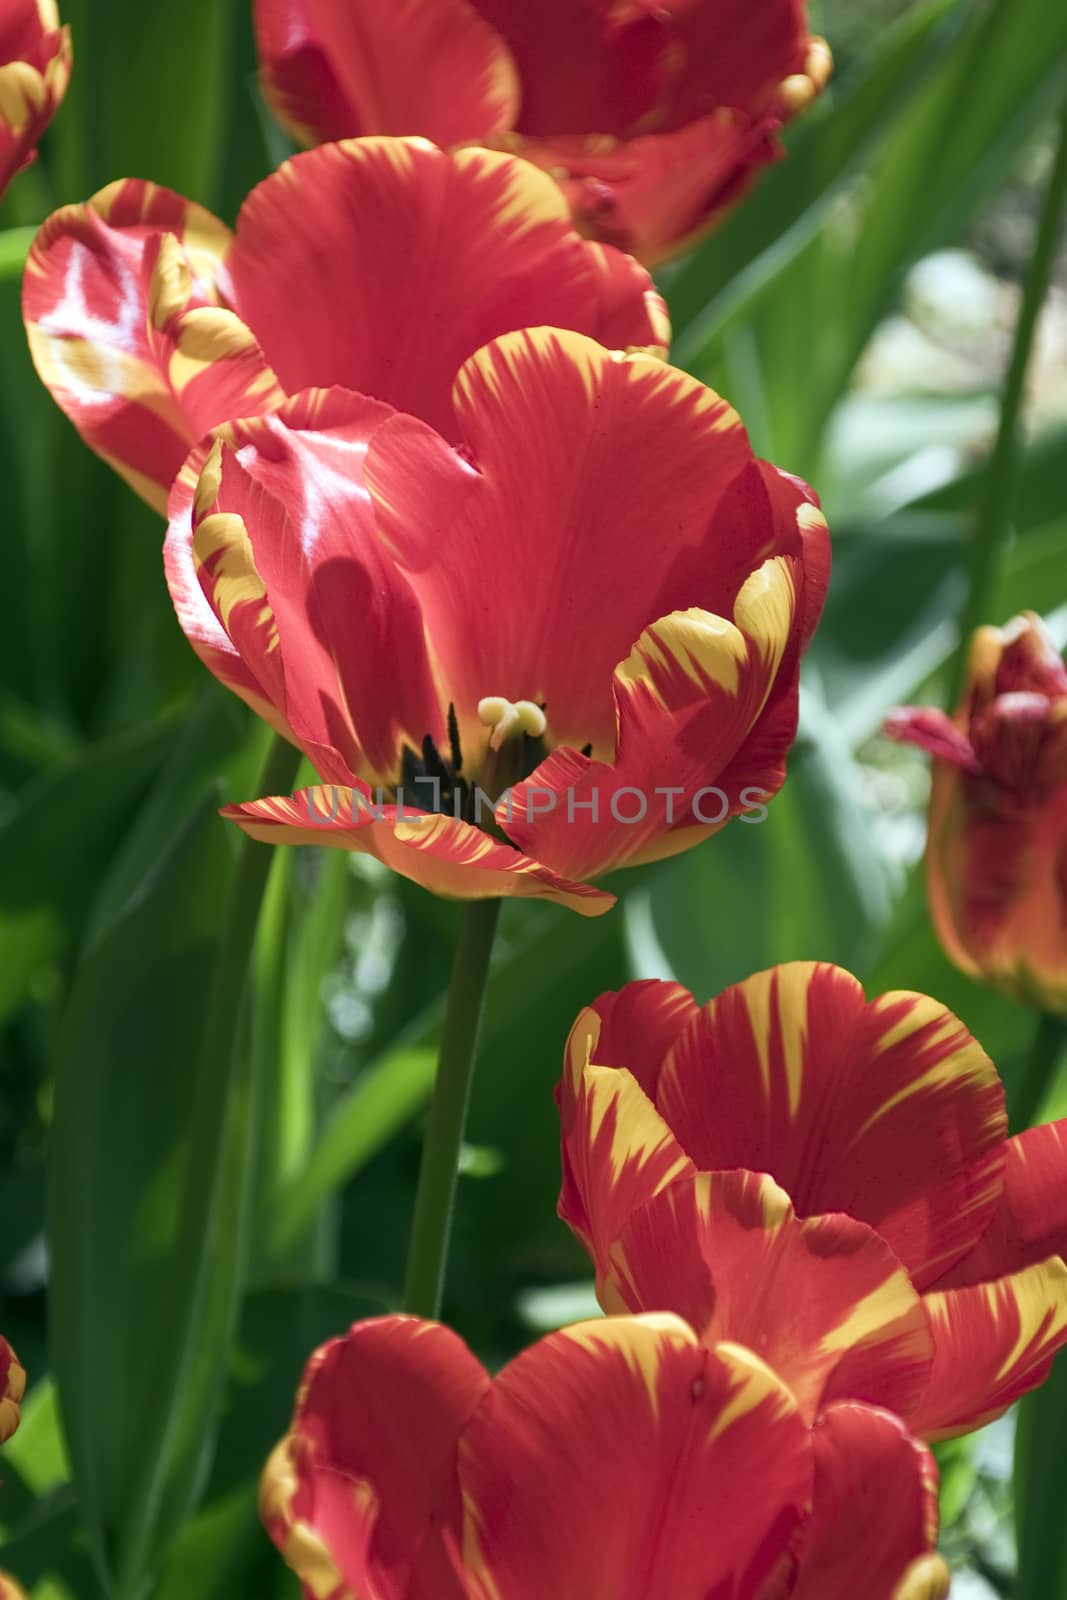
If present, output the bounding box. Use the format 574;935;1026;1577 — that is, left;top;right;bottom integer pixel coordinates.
403;899;501;1317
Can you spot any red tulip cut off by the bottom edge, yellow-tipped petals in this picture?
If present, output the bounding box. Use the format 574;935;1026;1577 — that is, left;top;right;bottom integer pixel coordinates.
261;1315;947;1600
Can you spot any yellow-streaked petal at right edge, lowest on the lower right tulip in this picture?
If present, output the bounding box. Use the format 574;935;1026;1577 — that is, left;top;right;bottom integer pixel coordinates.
909;1256;1067;1438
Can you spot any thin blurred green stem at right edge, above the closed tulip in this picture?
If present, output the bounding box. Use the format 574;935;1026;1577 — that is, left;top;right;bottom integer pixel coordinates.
952;104;1067;706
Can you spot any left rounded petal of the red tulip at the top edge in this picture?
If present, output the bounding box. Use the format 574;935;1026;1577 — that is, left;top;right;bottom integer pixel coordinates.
254;0;518;144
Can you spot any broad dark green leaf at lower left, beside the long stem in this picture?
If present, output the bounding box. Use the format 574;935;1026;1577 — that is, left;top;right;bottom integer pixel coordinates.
50;693;267;1574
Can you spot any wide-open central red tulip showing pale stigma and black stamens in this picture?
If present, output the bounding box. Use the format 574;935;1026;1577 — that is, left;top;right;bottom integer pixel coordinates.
166;328;829;915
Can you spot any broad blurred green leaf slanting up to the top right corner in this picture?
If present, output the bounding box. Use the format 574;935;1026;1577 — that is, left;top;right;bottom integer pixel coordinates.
681;0;1067;477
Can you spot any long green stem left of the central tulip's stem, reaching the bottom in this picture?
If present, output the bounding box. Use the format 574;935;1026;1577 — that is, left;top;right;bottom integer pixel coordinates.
118;736;301;1600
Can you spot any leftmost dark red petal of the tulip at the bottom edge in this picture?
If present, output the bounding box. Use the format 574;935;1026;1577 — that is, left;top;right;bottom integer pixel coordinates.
261;1317;490;1600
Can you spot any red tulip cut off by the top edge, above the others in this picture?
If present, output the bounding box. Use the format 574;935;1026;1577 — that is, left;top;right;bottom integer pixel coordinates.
254;0;830;262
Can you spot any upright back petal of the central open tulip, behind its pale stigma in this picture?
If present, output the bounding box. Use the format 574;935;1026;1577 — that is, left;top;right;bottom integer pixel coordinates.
366;328;798;761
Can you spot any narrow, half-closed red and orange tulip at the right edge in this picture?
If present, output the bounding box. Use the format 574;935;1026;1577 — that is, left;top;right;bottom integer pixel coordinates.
886;613;1067;1013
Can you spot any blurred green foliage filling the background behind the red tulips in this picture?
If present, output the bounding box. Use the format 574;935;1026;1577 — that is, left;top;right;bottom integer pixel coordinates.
0;0;1067;1600
